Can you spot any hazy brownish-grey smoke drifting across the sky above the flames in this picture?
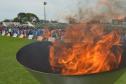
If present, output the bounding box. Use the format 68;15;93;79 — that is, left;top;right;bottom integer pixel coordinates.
67;0;126;22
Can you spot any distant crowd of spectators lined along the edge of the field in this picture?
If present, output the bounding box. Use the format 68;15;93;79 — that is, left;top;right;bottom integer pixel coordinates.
0;27;64;42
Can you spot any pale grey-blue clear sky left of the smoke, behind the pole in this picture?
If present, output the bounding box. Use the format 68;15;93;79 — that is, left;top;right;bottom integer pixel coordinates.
0;0;77;21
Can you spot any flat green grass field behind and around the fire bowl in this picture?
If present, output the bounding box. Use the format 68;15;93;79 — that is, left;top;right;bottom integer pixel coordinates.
0;36;126;84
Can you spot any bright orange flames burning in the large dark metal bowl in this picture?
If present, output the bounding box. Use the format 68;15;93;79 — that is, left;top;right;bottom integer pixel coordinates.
50;23;122;75
